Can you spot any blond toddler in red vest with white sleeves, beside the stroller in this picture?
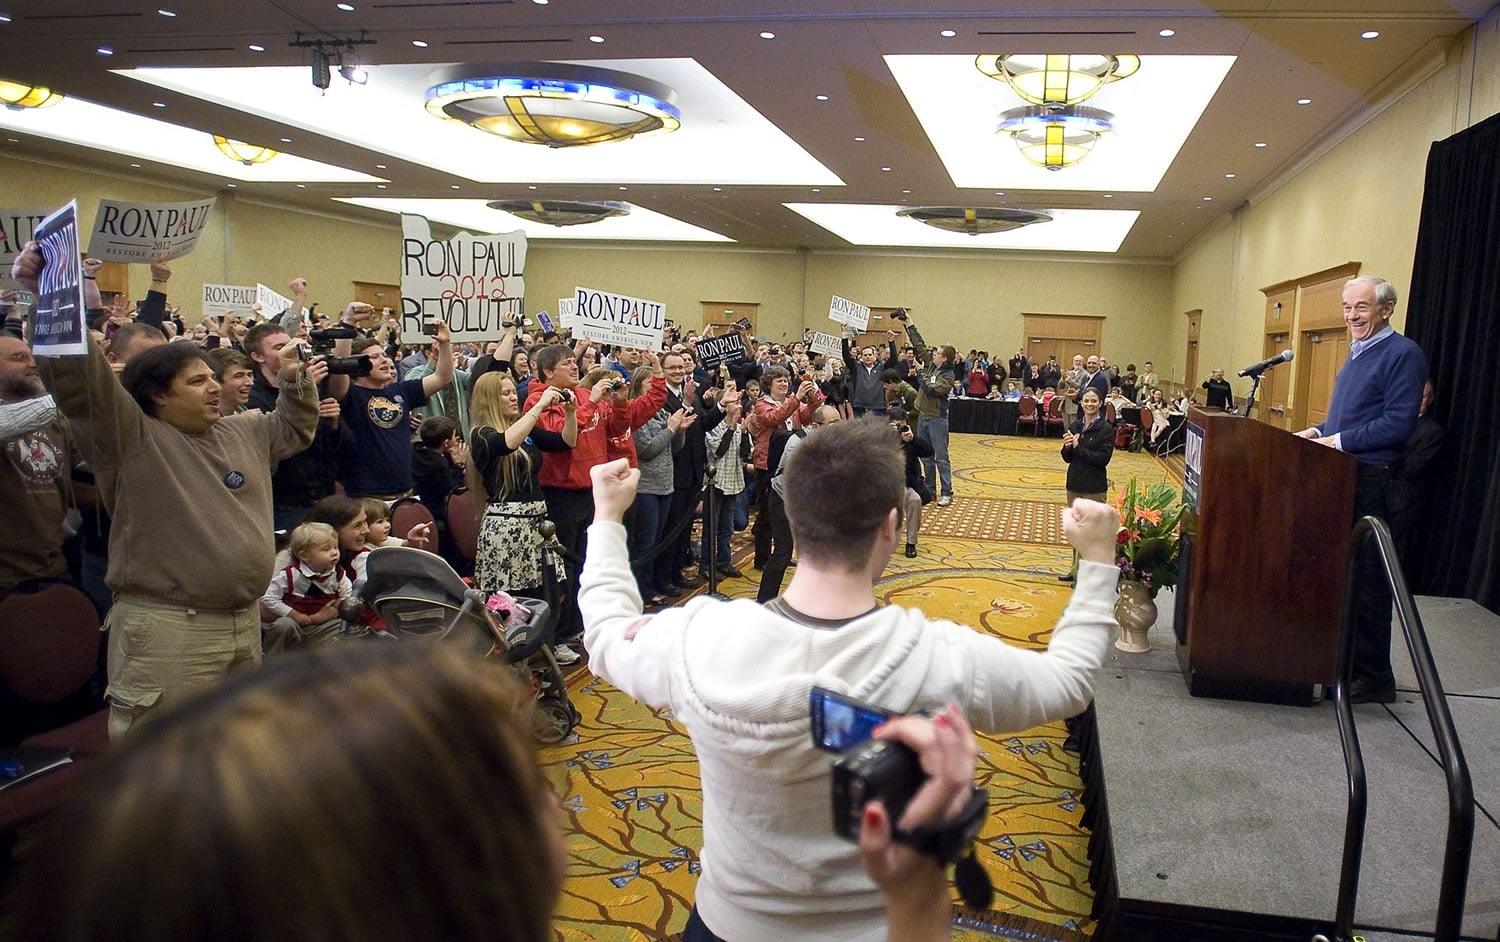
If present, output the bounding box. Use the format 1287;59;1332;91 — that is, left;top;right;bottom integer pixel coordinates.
261;524;354;654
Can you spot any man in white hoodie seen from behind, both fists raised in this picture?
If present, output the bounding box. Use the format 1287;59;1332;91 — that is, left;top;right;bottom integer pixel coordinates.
579;420;1119;942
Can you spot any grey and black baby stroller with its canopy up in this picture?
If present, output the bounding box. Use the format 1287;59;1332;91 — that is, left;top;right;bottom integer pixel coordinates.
363;546;579;743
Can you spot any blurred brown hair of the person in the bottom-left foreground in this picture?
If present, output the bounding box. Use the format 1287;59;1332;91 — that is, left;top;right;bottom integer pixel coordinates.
18;644;558;942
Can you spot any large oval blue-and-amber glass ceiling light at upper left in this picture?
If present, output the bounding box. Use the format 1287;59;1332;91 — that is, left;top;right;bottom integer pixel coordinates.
428;62;683;147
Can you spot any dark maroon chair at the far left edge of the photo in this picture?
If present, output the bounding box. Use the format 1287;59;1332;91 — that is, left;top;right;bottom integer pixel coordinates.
0;579;110;834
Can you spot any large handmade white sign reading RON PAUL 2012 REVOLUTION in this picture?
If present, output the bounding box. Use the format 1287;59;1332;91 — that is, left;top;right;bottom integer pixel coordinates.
401;213;527;344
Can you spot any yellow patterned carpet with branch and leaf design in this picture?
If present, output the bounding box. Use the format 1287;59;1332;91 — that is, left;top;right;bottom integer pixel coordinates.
542;435;1173;942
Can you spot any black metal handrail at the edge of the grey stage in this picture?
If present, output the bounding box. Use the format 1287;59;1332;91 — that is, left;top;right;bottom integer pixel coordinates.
1334;518;1475;942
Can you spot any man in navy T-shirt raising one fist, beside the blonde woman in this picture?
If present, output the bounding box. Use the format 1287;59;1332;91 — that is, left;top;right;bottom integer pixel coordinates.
335;318;453;501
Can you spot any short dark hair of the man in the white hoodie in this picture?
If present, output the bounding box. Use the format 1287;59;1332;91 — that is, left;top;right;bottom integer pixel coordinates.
782;416;906;572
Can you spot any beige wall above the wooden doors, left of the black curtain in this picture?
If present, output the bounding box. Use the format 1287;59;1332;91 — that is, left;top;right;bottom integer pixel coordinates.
1158;9;1500;405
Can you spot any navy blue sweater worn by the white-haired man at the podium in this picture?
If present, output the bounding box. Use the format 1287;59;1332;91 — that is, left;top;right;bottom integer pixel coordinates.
1319;333;1427;465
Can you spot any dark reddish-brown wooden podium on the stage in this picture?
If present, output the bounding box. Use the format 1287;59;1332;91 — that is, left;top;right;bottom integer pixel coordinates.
1173;408;1356;704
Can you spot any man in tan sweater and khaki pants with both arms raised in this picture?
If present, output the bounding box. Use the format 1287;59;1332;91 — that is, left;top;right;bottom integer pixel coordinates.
11;242;319;740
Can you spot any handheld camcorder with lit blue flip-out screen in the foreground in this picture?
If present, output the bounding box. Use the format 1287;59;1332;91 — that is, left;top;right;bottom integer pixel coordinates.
809;687;927;842
